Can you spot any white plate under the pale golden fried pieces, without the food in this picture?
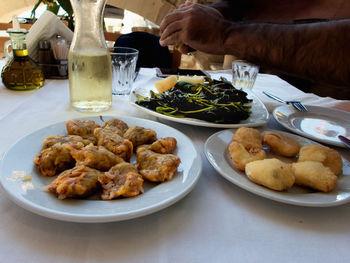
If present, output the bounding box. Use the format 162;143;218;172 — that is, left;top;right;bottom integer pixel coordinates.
205;129;350;207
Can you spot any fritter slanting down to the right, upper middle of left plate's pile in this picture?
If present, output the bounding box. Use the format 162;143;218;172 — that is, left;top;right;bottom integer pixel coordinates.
94;128;133;162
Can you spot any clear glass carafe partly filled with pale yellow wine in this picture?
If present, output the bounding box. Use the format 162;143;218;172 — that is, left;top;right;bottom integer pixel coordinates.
68;0;112;112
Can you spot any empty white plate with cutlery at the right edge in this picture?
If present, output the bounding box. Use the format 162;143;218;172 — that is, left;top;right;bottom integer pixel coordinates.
273;105;350;147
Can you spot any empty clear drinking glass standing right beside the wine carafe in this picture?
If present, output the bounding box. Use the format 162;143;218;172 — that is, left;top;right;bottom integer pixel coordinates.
111;47;139;95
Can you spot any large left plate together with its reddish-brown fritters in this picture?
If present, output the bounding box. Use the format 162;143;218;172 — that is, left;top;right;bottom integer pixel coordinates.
0;116;202;223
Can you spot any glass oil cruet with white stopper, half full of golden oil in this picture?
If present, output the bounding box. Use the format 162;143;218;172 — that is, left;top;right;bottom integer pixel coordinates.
1;17;44;90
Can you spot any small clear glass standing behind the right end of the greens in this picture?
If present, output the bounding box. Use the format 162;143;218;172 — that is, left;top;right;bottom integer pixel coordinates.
232;60;259;89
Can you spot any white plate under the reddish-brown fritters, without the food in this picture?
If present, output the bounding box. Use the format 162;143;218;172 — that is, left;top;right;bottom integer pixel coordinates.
0;116;202;223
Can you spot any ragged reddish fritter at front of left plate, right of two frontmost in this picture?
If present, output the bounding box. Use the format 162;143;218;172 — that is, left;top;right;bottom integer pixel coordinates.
98;162;143;200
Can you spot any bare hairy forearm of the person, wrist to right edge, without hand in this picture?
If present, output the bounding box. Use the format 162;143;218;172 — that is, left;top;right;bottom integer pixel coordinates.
224;20;350;86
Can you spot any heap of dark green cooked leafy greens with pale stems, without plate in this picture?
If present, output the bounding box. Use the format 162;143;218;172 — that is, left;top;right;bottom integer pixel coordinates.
136;78;252;123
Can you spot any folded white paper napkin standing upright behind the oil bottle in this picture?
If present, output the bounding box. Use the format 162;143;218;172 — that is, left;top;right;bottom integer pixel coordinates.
26;11;73;61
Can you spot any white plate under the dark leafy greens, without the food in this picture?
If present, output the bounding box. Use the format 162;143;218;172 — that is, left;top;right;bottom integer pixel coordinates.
130;78;269;128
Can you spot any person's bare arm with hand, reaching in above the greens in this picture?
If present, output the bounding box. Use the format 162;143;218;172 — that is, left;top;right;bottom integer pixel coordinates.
160;4;350;86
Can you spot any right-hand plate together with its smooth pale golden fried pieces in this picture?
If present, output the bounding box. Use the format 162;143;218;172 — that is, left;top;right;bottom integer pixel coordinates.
205;127;350;207
